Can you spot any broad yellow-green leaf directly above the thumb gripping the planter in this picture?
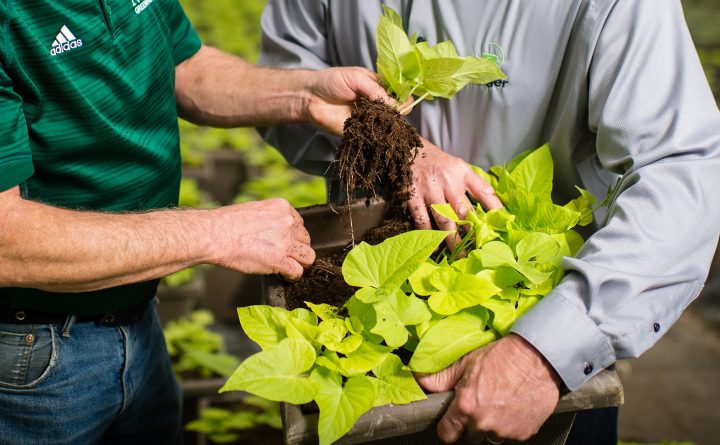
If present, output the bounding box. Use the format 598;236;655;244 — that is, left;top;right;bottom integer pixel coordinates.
410;307;496;372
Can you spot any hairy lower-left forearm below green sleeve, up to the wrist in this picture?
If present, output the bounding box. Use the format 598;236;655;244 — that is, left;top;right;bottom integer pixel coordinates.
0;189;212;292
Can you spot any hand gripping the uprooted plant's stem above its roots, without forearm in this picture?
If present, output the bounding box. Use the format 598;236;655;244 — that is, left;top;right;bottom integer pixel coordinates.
307;67;395;136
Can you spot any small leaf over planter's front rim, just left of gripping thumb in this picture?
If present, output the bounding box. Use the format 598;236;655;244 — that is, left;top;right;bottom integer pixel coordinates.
373;354;427;406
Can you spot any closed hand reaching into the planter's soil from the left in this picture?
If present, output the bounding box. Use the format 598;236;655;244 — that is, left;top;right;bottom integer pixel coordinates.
208;198;315;280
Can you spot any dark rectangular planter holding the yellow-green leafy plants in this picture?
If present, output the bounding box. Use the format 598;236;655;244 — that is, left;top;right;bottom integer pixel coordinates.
263;200;623;445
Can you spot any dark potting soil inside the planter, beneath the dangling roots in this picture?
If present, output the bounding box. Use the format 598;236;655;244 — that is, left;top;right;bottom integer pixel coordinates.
284;216;411;310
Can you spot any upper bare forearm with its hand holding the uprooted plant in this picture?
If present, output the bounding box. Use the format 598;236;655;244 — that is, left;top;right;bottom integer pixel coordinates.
175;46;393;134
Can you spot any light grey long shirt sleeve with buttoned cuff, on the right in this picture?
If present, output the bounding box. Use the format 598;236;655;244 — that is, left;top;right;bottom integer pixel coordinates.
513;0;720;390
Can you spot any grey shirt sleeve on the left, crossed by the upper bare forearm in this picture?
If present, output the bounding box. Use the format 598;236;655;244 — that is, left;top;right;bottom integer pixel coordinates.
258;0;339;175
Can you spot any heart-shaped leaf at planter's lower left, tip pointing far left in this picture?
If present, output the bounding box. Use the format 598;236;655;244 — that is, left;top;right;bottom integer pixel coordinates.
220;338;318;404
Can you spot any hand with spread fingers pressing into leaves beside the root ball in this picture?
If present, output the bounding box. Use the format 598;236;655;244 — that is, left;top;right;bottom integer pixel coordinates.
408;138;502;245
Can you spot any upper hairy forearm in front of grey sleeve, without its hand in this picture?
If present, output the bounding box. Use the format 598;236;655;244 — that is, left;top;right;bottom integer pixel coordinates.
175;47;311;127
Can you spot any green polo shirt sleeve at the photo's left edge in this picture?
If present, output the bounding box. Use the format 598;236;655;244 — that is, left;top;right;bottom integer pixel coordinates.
0;50;35;192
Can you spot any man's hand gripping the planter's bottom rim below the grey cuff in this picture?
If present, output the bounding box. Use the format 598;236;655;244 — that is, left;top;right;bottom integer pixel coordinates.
417;334;560;444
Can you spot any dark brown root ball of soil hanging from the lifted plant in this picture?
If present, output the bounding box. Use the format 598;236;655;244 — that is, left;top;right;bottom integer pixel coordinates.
336;98;422;207
